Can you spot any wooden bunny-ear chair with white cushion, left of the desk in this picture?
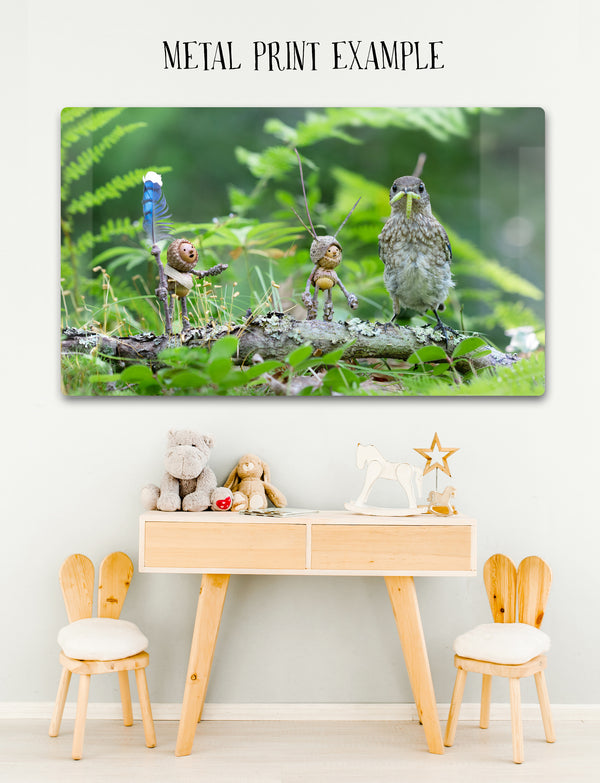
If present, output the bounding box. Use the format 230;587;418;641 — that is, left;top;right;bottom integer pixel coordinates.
49;552;156;759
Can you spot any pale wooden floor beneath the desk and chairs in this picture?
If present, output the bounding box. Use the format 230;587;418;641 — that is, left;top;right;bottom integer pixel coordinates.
0;719;600;783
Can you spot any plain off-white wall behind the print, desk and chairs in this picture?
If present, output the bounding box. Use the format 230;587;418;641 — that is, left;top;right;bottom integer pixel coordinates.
0;0;600;703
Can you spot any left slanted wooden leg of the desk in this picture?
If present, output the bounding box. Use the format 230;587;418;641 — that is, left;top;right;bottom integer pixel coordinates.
175;574;229;756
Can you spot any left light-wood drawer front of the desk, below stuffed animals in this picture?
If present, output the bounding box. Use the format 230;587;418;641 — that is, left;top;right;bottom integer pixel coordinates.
144;522;306;571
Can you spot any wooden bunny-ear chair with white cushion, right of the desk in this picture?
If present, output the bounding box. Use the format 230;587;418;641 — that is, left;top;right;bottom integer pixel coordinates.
444;554;555;764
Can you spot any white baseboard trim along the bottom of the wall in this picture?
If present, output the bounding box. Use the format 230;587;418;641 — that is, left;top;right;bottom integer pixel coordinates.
0;701;600;721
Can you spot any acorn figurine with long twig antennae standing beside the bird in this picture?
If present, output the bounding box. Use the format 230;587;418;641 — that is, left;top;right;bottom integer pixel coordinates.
294;150;360;321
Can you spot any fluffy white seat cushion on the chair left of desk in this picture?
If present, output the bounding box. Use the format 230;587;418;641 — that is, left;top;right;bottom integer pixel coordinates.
58;617;148;661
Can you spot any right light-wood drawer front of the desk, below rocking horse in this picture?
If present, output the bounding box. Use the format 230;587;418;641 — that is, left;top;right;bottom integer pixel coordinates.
311;525;473;572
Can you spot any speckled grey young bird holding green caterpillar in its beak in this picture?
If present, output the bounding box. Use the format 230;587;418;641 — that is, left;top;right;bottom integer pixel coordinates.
379;177;454;345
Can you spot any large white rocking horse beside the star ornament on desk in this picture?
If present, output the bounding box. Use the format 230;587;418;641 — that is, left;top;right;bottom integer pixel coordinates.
345;443;425;516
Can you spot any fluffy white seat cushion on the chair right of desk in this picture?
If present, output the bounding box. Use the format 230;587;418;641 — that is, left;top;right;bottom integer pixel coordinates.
454;623;550;664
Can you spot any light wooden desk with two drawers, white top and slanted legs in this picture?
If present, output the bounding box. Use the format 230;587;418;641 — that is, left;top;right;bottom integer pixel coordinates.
139;511;476;756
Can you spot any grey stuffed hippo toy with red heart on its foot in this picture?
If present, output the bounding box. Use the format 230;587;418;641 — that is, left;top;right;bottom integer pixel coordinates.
142;430;232;511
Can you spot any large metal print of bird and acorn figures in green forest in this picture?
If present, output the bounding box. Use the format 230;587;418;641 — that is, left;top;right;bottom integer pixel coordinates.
61;107;545;397
